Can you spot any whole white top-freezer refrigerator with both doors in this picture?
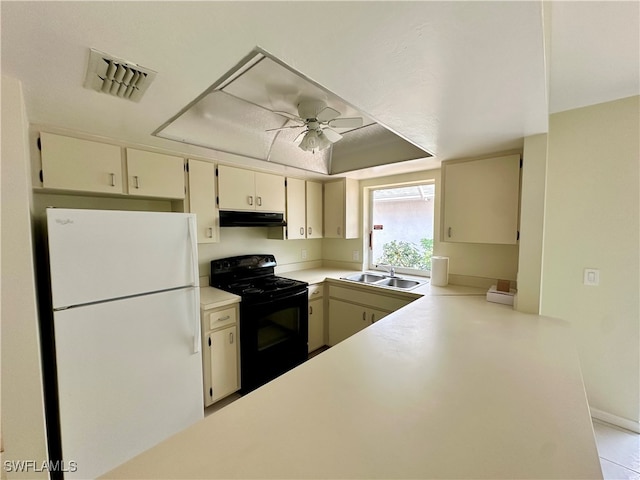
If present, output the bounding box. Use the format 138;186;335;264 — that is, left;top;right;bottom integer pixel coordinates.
45;208;204;479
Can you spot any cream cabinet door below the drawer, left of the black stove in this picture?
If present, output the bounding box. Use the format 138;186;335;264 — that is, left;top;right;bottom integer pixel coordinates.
209;325;238;402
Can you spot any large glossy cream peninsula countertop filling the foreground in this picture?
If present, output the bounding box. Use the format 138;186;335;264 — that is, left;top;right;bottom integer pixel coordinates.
104;295;602;479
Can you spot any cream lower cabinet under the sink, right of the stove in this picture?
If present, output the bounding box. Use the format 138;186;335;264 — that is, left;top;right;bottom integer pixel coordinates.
328;283;418;346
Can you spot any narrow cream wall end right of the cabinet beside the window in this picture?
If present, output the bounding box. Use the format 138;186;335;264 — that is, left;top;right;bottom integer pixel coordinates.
516;133;547;313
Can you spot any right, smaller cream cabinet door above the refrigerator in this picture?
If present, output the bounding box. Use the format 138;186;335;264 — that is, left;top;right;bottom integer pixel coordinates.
127;148;185;198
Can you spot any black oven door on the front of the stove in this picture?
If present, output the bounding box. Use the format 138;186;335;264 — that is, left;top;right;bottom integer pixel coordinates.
240;289;309;393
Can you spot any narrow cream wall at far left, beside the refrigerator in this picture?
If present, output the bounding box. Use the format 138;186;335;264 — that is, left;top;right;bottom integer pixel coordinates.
0;76;47;478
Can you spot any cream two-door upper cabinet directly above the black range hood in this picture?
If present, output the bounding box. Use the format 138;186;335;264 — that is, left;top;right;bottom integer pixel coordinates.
218;165;285;212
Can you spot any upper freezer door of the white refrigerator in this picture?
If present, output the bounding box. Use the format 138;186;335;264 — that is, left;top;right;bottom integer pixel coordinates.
47;208;198;309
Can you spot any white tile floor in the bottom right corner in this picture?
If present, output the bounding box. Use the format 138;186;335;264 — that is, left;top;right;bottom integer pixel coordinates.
593;420;640;480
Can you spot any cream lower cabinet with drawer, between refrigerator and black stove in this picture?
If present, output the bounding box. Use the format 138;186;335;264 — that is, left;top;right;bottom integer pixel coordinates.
201;305;240;407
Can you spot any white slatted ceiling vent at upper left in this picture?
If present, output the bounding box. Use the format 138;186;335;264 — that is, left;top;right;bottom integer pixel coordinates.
84;48;156;102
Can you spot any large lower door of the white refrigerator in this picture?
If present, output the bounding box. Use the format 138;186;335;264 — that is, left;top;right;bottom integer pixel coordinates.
54;288;204;479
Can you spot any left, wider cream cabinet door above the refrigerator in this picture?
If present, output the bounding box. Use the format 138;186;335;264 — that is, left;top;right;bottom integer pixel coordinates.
40;133;124;194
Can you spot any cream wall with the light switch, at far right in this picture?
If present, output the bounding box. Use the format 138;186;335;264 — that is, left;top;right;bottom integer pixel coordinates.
541;96;640;428
